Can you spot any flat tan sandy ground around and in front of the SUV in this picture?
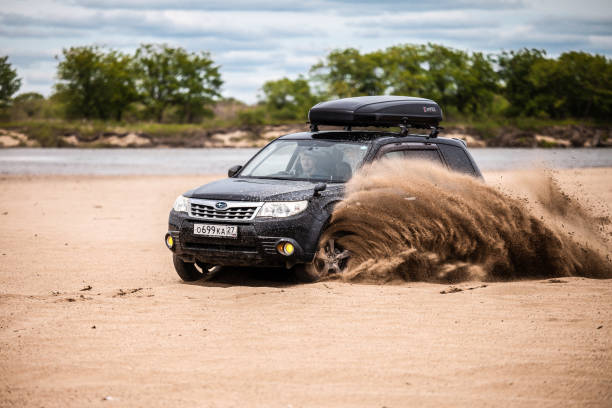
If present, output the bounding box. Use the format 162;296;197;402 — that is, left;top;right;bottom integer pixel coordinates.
0;168;612;408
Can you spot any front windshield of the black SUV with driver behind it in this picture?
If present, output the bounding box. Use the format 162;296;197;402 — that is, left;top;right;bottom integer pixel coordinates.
240;140;370;183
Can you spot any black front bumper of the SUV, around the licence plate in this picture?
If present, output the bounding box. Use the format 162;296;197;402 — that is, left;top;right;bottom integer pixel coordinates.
163;210;326;267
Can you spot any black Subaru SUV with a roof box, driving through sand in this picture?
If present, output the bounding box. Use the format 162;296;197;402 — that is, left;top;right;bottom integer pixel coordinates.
166;96;482;281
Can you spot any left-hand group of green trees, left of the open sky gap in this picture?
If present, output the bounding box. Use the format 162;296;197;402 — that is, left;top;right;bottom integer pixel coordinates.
0;44;223;122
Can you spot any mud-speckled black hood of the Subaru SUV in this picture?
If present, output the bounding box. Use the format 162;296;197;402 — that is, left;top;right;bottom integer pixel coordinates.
184;178;343;201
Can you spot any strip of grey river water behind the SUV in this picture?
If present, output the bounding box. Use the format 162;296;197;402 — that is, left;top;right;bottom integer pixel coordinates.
0;148;612;175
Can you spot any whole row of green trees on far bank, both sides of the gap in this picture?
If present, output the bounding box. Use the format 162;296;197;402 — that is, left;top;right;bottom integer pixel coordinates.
0;44;612;124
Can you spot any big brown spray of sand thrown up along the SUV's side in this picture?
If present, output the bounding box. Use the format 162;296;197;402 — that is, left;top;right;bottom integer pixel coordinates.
323;160;612;282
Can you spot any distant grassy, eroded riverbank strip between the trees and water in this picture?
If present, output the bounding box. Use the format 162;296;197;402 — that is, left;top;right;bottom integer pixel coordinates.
0;124;612;148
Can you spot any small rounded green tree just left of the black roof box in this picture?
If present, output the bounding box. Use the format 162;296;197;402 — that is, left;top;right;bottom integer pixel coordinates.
262;77;317;121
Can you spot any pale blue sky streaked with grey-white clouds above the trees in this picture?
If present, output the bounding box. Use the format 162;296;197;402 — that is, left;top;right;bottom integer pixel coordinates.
0;0;612;103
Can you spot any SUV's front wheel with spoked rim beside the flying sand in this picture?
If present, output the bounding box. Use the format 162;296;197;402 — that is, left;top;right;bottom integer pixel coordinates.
294;238;350;283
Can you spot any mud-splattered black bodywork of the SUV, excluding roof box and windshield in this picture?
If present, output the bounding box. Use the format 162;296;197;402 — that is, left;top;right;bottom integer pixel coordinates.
166;131;482;280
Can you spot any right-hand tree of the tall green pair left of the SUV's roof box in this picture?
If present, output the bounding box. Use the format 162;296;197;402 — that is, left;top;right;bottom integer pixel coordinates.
136;44;223;122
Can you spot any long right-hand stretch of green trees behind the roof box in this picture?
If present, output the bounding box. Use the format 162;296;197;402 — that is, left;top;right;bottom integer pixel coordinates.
263;44;612;121
